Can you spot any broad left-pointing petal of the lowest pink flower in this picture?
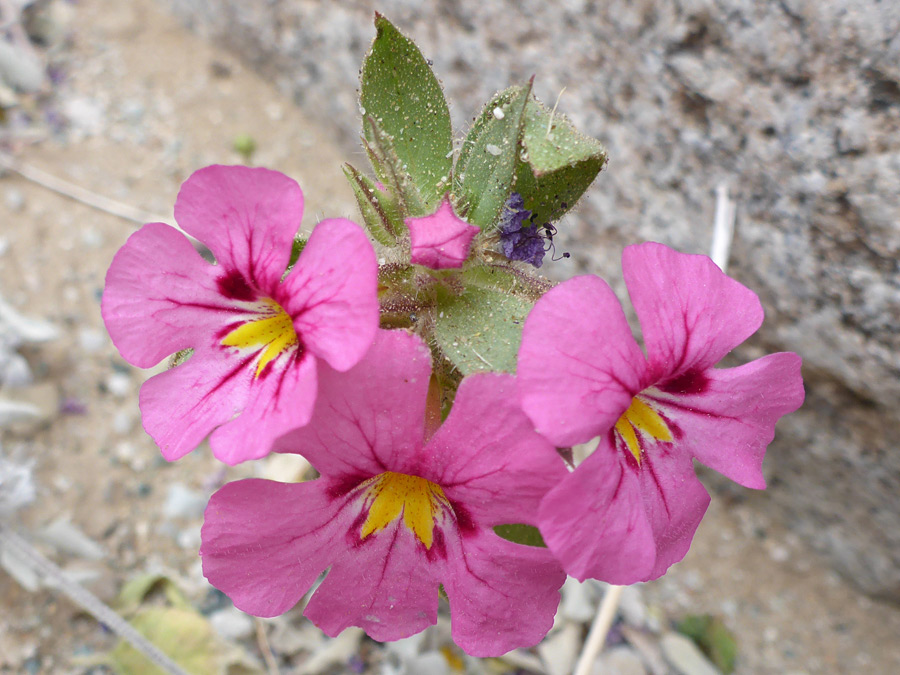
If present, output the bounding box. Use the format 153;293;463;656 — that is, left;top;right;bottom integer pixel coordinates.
200;479;344;616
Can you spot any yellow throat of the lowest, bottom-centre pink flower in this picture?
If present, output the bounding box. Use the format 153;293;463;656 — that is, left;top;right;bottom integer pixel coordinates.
360;471;450;549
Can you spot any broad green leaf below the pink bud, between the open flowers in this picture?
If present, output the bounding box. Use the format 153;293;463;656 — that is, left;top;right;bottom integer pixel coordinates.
434;287;533;375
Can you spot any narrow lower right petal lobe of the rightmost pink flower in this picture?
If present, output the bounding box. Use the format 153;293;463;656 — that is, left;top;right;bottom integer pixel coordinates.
634;446;710;581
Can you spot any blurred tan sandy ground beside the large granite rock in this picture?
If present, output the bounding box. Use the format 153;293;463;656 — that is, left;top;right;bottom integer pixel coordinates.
0;0;900;674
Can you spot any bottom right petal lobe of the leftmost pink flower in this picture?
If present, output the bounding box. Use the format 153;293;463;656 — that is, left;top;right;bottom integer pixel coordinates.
209;354;317;465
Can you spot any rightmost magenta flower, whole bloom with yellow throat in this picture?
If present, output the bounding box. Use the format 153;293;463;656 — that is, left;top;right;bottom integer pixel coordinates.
517;243;803;584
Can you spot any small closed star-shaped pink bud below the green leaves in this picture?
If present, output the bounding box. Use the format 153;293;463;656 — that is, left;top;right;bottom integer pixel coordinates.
404;197;479;270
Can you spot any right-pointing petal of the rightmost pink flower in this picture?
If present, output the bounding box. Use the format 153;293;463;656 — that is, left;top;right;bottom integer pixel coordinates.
648;352;803;489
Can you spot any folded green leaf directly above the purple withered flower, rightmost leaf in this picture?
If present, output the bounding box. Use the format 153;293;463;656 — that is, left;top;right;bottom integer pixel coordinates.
514;97;607;225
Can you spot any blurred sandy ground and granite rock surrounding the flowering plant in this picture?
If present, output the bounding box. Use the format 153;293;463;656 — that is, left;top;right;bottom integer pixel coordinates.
0;0;900;675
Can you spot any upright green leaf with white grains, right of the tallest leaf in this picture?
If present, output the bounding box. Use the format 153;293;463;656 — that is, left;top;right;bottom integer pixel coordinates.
453;82;531;230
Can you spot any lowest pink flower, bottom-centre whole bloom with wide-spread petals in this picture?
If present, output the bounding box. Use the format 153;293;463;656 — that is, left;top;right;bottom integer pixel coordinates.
200;331;566;656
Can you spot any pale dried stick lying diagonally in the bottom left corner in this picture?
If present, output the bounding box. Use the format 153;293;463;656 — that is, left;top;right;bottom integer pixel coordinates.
0;523;188;675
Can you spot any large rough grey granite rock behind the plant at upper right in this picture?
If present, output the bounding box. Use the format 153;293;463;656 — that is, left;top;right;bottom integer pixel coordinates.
164;0;900;602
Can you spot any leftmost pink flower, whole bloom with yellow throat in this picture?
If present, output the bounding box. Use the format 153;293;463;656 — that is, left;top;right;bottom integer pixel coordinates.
102;166;378;464
